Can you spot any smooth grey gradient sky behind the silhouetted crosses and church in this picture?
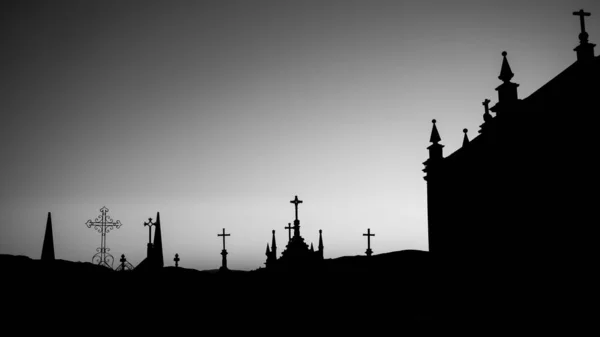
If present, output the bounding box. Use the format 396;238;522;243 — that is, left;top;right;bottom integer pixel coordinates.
0;0;600;270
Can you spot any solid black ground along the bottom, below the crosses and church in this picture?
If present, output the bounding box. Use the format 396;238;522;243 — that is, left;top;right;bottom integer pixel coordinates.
0;252;593;330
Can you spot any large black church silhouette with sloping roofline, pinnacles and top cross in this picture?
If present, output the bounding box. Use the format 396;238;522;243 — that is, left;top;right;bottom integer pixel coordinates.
423;10;600;267
